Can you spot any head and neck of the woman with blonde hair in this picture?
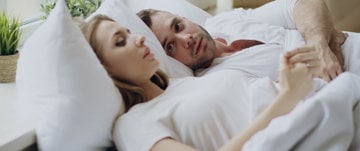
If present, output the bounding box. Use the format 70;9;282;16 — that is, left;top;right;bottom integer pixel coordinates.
82;16;168;111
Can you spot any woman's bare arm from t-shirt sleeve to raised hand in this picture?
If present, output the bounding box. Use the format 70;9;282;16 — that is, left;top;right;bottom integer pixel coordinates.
151;51;319;151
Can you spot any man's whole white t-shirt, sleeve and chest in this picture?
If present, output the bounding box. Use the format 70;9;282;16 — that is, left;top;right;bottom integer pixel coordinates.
200;0;304;81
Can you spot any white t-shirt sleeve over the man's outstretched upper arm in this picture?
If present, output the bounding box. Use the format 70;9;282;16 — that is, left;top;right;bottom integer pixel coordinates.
204;0;301;45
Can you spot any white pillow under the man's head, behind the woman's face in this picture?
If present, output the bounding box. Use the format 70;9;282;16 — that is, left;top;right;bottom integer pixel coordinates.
87;0;211;77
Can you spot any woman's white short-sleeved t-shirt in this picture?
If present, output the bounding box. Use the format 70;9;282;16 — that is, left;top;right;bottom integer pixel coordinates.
114;70;276;151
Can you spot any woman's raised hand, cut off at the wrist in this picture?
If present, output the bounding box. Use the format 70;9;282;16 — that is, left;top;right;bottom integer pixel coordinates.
279;55;317;104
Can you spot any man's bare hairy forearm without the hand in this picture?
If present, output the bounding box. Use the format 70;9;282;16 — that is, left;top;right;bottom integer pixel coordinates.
293;0;334;44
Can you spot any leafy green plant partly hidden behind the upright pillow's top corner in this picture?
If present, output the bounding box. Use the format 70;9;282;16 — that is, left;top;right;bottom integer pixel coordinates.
41;0;101;20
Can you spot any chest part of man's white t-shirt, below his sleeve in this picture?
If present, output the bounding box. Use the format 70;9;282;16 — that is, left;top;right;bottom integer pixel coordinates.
195;43;284;81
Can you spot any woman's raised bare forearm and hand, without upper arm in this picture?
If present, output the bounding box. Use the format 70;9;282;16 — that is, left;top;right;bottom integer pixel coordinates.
220;54;312;151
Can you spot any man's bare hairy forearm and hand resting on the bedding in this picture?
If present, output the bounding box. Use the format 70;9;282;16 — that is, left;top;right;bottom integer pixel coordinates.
293;0;346;81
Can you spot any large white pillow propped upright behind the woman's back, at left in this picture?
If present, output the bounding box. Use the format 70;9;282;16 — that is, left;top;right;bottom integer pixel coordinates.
16;0;124;151
